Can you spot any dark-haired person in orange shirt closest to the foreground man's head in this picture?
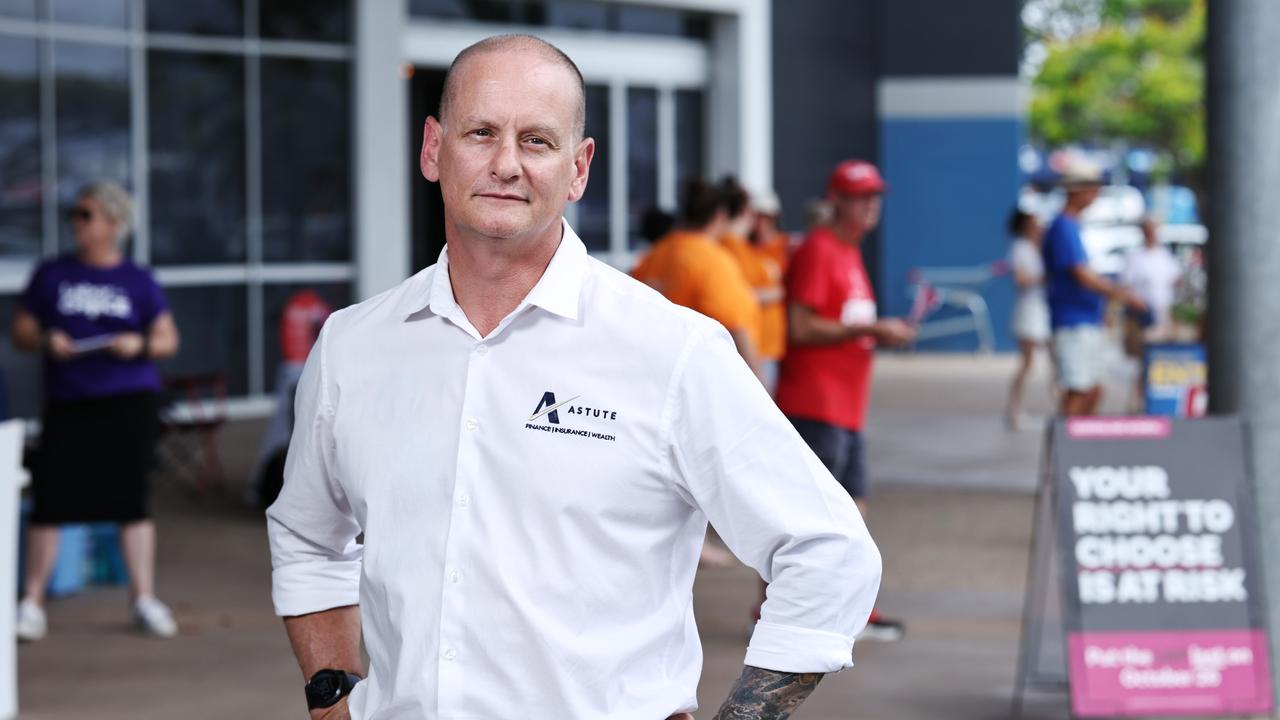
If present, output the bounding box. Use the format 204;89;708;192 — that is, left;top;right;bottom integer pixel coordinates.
631;181;763;382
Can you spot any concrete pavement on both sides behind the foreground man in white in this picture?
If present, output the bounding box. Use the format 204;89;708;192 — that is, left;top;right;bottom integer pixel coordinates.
19;355;1066;720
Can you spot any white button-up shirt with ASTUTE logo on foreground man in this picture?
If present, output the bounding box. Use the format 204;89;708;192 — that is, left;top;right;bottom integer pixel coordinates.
268;224;881;720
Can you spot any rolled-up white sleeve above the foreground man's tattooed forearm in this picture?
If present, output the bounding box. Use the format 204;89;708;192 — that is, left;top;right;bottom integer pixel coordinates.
666;322;881;673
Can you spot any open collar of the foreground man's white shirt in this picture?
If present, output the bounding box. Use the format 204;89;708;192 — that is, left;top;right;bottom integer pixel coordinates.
401;219;588;320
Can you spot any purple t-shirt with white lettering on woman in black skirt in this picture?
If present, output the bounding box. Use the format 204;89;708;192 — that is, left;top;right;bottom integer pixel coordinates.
22;255;169;401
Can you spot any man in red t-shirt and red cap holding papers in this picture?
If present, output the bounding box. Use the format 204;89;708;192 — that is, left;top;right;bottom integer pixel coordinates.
777;160;915;641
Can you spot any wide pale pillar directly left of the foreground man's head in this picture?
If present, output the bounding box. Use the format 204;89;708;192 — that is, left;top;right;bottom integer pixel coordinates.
352;1;412;300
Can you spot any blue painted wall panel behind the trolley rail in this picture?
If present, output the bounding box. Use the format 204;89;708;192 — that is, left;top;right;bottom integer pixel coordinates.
876;118;1024;350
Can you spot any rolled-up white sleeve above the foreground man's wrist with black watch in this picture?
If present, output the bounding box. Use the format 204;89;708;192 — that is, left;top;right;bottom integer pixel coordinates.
266;325;361;616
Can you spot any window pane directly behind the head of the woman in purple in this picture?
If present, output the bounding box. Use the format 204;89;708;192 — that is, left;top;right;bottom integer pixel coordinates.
54;42;131;250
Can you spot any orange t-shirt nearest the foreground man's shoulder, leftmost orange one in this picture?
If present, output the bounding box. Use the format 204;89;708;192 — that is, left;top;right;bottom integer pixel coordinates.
631;231;760;347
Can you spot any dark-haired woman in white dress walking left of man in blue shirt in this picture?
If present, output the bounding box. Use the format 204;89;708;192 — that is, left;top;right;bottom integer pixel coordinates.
1005;209;1051;429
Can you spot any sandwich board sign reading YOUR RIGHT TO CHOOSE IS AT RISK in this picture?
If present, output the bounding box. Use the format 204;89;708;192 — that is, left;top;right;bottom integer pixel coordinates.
1015;416;1272;717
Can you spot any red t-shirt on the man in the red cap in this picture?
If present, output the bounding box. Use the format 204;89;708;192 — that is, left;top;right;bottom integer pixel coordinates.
777;228;876;430
